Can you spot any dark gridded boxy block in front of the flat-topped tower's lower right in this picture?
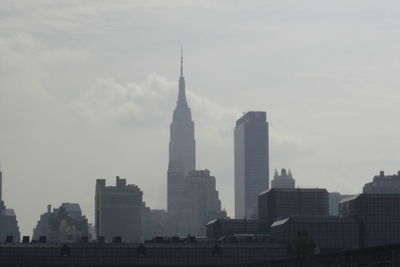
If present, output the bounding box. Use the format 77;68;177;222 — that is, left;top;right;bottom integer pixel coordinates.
258;188;329;228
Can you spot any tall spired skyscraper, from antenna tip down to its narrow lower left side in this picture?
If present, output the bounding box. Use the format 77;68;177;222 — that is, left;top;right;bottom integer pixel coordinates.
167;51;196;228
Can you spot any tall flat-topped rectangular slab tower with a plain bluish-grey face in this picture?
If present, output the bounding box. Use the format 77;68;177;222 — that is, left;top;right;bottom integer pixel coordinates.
234;111;269;219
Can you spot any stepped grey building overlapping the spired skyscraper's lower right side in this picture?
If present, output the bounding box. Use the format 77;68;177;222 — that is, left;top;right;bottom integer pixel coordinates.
178;170;226;235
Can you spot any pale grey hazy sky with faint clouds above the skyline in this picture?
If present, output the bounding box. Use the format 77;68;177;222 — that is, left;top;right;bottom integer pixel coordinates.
0;0;400;235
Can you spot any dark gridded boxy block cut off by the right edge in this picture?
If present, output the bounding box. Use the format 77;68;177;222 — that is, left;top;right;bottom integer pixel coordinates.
339;194;400;247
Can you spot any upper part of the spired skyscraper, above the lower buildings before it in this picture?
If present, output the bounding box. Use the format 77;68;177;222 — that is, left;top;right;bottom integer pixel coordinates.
169;50;196;176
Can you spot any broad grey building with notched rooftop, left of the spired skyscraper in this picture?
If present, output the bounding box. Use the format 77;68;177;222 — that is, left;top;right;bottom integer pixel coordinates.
95;176;143;242
